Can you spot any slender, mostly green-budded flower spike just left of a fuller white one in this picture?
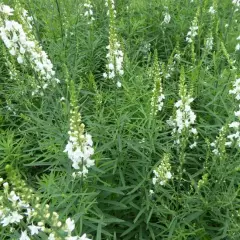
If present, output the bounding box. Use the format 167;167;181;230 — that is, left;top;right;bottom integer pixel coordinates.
150;50;165;116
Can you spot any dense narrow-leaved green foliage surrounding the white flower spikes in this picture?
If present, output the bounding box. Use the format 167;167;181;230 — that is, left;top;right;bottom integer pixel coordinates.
0;0;240;240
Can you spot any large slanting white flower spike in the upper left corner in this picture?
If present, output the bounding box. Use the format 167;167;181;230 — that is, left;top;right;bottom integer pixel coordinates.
0;4;59;95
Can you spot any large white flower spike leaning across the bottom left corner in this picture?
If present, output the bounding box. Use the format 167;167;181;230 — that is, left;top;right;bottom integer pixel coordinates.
0;166;90;240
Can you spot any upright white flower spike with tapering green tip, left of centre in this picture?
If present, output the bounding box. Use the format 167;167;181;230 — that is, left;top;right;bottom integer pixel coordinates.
64;82;94;177
